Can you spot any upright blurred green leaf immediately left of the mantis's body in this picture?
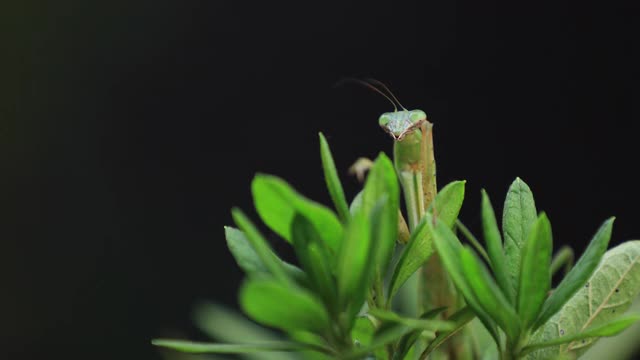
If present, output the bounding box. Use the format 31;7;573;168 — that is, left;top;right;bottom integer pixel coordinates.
361;153;400;275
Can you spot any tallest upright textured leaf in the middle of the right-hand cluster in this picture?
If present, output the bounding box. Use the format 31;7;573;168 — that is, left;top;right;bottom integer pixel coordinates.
502;178;538;299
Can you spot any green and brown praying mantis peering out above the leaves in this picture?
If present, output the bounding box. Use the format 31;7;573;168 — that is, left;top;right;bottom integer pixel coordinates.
350;79;466;358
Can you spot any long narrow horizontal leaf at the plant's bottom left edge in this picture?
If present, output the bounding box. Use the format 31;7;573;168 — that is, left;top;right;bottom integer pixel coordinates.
151;339;307;354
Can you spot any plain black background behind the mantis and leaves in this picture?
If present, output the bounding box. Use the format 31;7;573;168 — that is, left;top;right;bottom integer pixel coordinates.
5;0;640;359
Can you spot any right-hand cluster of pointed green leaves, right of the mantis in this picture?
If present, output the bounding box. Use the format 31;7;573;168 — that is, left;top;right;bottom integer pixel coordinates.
427;178;640;359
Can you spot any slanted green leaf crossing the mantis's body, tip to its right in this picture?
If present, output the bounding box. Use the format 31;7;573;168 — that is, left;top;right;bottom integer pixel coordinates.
389;181;465;299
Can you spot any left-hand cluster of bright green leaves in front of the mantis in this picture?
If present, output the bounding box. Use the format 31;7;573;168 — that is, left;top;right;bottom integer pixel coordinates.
154;134;462;359
